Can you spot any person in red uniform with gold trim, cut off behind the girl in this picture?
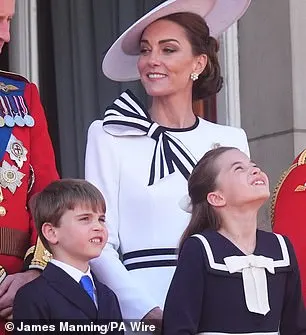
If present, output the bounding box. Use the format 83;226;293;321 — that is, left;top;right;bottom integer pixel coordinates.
272;150;306;303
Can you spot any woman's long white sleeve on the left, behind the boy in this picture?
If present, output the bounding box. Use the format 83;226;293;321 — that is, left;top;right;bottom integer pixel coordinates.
85;121;156;319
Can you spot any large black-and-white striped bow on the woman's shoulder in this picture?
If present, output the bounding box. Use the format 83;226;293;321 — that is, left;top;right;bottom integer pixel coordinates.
103;90;198;186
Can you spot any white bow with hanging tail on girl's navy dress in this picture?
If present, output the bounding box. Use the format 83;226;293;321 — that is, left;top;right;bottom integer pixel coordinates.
224;255;275;315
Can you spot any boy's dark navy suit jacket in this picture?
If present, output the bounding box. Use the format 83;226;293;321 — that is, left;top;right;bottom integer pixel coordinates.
13;263;123;334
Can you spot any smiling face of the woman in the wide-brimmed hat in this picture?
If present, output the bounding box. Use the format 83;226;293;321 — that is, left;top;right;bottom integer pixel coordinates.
137;20;203;97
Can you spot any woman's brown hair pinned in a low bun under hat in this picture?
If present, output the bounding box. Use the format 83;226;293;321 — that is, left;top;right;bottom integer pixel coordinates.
159;12;223;100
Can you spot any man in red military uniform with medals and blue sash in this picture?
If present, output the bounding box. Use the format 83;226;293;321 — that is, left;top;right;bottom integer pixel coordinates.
0;0;58;334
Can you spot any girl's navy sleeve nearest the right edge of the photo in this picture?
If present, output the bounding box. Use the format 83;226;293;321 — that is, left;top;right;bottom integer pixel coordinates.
280;238;306;335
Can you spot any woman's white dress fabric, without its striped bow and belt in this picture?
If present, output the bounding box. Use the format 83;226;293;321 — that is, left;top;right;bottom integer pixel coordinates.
85;119;249;319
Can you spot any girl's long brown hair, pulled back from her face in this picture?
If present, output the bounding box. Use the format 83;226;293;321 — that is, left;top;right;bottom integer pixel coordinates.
180;147;238;248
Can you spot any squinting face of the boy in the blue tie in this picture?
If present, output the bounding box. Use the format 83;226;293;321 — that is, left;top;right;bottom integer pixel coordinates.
46;206;108;271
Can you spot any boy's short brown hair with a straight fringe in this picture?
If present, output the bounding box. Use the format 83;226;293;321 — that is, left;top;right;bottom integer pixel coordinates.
30;179;106;252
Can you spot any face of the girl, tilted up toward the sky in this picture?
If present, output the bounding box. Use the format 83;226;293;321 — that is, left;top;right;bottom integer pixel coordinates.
212;149;270;207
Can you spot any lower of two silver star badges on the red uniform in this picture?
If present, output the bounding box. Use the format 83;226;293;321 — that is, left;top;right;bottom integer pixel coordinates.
0;161;25;194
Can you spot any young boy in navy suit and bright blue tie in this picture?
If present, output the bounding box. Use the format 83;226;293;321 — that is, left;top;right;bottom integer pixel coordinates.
13;179;122;334
